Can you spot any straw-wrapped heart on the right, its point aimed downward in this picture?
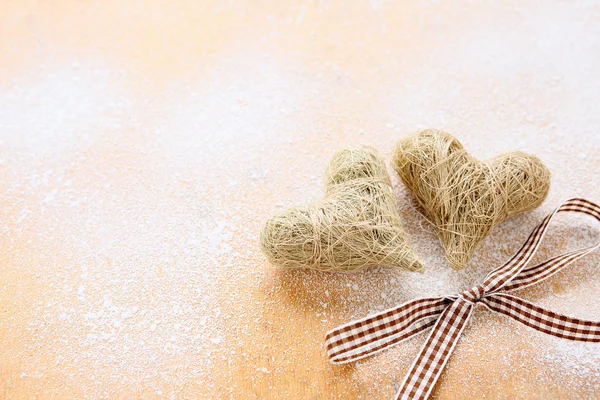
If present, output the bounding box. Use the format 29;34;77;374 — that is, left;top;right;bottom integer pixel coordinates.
392;130;550;268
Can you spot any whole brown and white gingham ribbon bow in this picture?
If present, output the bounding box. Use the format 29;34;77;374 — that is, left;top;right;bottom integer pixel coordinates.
326;198;600;399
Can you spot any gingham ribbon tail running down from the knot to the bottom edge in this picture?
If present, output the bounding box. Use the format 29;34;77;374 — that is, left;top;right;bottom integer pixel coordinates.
395;299;474;400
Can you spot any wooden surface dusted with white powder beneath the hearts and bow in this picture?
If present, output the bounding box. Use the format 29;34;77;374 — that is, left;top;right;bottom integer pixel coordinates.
0;0;600;399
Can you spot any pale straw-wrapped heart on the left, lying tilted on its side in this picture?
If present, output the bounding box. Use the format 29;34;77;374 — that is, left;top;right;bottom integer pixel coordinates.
261;147;423;272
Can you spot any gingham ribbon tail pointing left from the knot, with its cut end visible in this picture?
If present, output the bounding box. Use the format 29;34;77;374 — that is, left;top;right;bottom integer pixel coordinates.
325;298;450;364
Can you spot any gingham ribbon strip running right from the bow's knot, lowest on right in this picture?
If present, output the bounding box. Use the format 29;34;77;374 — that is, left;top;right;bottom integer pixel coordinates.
480;293;600;342
